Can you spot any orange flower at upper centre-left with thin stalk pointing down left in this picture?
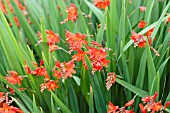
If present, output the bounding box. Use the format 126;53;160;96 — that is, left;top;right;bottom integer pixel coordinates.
61;4;78;24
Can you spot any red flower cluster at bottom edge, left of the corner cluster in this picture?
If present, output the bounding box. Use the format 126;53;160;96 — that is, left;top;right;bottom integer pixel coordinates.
107;99;134;113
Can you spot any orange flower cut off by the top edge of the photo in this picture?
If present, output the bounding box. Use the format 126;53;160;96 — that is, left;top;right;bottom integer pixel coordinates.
94;0;110;10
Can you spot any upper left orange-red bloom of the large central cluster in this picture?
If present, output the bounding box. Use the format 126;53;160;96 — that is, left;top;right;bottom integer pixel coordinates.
66;30;87;50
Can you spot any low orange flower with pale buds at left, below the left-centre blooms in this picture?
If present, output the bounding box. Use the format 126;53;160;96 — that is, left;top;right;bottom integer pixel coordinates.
40;80;59;92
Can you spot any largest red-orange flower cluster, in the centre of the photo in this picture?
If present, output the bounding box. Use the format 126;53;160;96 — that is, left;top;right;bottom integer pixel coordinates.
66;31;110;74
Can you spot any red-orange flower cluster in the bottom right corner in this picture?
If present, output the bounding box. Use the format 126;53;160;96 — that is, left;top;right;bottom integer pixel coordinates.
139;92;170;113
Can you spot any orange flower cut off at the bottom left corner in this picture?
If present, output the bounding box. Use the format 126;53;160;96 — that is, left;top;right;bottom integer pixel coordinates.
0;103;24;113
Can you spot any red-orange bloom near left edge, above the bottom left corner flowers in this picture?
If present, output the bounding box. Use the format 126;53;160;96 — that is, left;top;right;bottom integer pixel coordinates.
5;71;23;85
